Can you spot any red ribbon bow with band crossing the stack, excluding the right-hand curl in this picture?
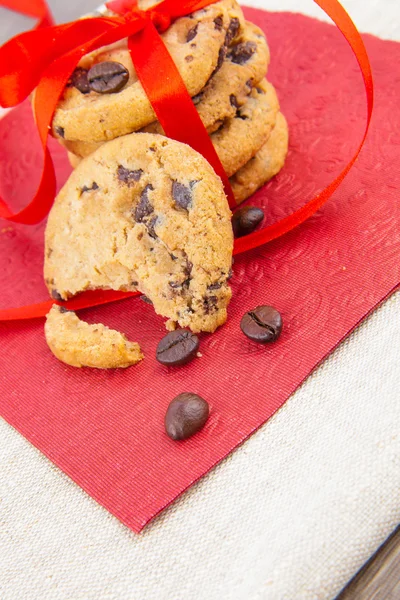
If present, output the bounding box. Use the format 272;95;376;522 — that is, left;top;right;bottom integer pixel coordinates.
0;0;234;224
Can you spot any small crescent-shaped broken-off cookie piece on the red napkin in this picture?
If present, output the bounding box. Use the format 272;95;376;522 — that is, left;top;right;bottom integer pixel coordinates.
44;304;143;369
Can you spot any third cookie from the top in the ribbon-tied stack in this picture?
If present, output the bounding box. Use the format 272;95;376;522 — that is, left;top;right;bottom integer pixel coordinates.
63;80;279;177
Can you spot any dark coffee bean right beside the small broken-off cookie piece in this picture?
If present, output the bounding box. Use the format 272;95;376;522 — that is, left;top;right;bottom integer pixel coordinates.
156;329;199;367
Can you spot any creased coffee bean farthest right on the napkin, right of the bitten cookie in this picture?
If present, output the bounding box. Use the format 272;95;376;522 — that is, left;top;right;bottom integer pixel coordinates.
240;306;282;344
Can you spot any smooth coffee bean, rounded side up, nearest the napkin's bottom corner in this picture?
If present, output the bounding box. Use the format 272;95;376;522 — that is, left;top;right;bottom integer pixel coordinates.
164;392;210;440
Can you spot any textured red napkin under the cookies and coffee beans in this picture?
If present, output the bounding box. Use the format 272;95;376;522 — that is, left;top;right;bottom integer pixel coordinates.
0;9;400;531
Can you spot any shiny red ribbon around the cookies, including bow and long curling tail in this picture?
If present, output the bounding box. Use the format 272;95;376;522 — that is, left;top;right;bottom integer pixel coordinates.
0;0;374;321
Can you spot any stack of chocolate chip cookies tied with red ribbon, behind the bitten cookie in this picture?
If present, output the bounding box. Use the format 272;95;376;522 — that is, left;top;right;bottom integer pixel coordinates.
53;0;288;203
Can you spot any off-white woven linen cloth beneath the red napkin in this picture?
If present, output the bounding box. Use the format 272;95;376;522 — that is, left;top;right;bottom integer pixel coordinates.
0;0;400;600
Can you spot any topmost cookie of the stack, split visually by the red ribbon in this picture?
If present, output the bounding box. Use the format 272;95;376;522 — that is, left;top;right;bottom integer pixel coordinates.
52;0;244;142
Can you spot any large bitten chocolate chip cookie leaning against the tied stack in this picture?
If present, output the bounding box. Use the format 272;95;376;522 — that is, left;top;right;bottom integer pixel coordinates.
45;133;233;332
